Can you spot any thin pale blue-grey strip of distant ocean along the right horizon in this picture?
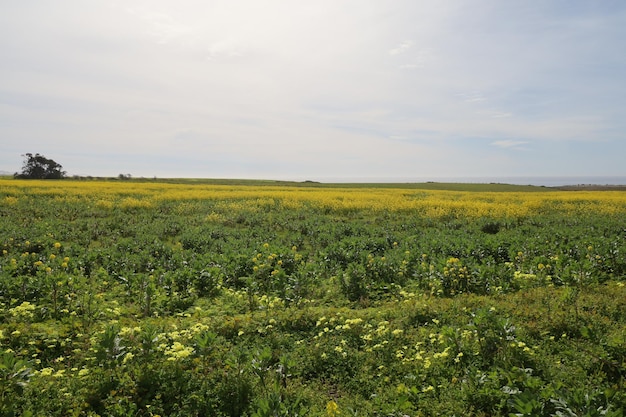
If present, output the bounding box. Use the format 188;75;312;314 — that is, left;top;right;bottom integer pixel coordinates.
320;176;626;187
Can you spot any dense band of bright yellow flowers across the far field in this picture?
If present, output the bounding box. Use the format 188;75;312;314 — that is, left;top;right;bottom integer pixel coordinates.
0;179;626;221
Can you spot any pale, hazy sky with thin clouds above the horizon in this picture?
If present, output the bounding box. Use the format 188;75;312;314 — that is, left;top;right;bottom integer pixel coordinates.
0;0;626;181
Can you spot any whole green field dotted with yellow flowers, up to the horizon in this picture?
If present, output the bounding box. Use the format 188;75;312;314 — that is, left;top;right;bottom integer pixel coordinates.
0;179;626;417
